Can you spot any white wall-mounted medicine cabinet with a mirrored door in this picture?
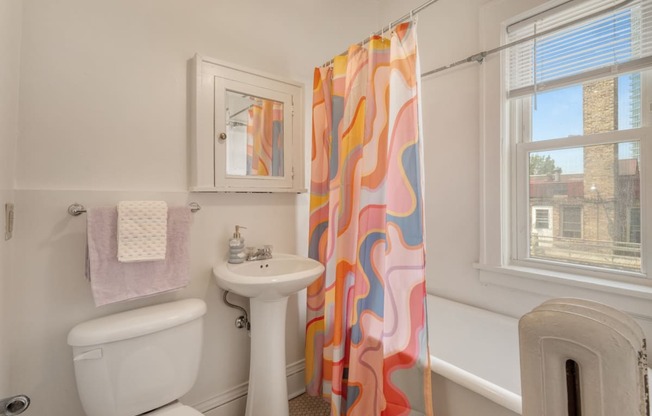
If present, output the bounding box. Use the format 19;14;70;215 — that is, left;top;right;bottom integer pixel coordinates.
190;55;306;192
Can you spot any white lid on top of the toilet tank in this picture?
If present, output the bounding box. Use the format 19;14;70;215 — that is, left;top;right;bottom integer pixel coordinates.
68;299;206;347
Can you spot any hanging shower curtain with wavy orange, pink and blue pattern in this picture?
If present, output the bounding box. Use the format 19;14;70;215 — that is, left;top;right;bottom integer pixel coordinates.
306;22;432;416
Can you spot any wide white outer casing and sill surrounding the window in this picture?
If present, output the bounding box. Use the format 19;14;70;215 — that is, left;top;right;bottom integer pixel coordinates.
474;0;652;300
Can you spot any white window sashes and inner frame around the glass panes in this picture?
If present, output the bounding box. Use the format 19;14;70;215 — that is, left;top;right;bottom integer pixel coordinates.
499;2;652;280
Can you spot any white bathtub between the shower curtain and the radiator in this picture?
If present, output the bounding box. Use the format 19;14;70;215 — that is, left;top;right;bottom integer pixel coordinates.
428;295;521;416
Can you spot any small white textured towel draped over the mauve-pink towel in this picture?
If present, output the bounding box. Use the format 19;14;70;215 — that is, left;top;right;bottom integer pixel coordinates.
118;201;168;263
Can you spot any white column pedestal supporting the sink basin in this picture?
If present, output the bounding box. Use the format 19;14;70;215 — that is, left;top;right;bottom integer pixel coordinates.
245;297;289;416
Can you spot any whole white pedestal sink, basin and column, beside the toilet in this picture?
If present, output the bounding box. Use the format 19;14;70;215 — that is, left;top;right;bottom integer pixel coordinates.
213;254;324;416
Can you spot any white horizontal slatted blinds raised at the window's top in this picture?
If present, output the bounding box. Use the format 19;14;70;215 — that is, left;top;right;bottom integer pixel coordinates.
507;0;652;98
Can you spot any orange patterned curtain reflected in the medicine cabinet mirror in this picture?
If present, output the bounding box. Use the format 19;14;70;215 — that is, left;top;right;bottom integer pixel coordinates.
247;100;283;176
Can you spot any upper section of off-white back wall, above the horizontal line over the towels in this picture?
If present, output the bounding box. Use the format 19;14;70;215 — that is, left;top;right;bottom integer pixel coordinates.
17;0;375;190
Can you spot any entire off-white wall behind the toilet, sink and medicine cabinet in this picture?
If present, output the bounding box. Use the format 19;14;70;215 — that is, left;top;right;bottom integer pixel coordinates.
8;0;380;416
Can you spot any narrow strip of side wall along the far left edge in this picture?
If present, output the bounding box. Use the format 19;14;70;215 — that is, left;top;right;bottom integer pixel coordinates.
0;0;21;398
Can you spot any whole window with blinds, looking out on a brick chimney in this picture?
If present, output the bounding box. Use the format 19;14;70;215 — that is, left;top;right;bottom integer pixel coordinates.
503;0;652;276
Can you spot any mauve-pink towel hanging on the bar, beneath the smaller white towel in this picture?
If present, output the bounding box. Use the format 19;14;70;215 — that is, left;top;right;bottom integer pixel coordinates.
86;207;192;306
